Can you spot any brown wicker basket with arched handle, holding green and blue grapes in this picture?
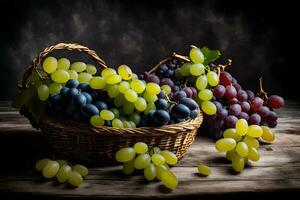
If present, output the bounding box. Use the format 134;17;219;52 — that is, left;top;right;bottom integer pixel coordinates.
22;43;202;164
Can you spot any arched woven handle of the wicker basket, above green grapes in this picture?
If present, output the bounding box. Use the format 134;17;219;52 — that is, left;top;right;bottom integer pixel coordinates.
22;43;107;88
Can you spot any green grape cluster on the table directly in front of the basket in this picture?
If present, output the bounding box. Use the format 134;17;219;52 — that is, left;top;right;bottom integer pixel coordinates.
115;142;178;189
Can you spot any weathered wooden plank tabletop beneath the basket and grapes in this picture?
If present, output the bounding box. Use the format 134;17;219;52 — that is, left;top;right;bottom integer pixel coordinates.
0;102;300;199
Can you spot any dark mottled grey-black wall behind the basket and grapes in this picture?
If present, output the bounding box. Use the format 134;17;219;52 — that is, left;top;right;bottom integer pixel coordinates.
0;0;299;100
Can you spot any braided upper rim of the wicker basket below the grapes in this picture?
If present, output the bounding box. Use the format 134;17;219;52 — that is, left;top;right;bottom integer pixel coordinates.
40;111;203;137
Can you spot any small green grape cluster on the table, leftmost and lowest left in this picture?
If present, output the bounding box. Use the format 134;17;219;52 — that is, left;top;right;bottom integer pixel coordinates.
35;158;89;187
